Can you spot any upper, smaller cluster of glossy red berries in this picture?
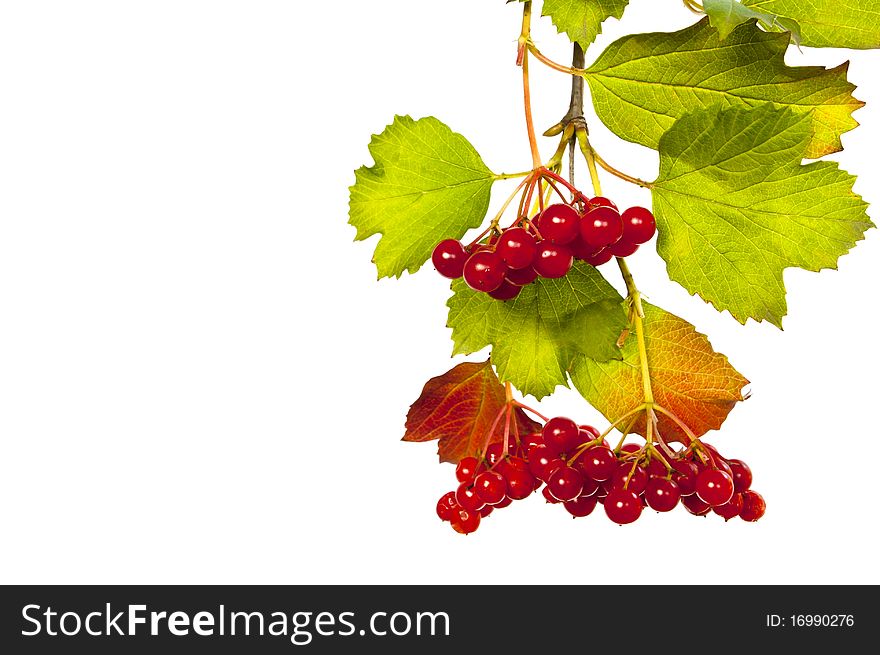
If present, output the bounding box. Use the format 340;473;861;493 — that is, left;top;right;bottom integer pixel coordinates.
431;197;656;300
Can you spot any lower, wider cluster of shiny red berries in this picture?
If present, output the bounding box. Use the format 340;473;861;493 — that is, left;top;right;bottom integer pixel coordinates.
437;417;765;534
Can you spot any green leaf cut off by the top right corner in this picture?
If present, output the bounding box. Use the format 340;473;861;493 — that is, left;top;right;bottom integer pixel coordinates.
743;0;880;49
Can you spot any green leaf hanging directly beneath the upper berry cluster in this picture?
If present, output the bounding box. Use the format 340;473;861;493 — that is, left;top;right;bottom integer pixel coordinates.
447;262;626;398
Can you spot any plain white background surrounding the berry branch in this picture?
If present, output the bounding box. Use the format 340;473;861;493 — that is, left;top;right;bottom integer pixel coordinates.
0;0;880;583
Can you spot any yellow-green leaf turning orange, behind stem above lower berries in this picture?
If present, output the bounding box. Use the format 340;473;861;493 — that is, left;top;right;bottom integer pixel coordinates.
571;304;749;441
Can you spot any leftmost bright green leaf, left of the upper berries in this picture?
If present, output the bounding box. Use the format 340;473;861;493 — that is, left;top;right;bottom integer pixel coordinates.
349;116;496;278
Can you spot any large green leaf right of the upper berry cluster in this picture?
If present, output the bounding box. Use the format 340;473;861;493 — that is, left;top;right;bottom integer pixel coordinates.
653;105;873;327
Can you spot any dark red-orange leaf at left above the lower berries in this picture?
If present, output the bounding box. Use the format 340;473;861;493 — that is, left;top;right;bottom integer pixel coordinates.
403;361;541;463
